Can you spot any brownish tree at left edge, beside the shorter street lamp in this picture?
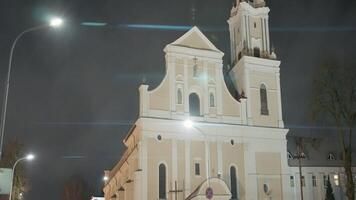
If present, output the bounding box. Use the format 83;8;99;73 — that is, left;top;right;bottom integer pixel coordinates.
0;138;28;200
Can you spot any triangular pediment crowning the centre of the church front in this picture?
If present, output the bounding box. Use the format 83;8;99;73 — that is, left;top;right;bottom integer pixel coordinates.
171;26;221;52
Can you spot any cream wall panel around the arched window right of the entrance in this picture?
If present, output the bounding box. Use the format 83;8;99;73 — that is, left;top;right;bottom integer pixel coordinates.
222;141;245;199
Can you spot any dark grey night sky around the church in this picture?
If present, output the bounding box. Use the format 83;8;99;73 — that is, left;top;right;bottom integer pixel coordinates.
0;0;356;200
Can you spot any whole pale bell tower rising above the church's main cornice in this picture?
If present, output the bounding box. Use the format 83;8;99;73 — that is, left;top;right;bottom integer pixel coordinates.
228;0;284;128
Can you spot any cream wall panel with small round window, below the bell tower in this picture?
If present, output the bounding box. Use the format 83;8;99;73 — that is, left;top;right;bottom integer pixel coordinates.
255;152;283;200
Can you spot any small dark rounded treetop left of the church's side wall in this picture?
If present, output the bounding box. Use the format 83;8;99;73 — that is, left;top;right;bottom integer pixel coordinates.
62;175;92;200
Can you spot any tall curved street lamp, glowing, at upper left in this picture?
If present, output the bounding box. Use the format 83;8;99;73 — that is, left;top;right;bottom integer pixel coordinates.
0;18;63;160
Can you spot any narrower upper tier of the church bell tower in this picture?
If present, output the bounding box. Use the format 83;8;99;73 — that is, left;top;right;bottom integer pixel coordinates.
228;0;275;64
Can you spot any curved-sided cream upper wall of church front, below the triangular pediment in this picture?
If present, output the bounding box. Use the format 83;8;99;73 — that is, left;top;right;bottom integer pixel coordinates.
145;46;241;120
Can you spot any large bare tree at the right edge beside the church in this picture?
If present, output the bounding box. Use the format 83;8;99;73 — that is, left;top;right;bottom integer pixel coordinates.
313;59;356;200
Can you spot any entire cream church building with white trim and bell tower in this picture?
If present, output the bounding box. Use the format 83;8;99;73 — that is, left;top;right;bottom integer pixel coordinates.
104;0;354;200
